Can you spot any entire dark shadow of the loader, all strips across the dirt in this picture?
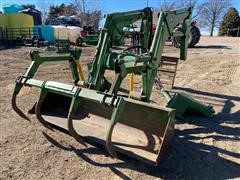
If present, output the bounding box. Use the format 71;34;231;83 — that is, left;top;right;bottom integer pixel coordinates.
43;88;240;179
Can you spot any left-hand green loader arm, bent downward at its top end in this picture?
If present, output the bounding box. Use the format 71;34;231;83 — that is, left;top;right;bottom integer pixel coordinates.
88;8;152;90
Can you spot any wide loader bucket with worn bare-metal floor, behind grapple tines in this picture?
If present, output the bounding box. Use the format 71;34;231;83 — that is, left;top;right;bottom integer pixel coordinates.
33;89;175;165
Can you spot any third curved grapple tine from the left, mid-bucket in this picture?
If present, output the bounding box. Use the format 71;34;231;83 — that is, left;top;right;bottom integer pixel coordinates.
68;97;87;147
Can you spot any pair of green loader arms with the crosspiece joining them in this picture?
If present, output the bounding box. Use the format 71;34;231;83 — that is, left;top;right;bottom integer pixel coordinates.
88;8;192;102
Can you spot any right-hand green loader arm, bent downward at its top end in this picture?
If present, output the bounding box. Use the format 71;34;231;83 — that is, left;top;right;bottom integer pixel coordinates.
141;8;192;101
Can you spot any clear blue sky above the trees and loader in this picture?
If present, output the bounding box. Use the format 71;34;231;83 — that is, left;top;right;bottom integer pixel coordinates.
0;0;240;34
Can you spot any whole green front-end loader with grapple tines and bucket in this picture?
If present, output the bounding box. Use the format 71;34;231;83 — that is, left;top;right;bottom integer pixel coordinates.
12;8;214;165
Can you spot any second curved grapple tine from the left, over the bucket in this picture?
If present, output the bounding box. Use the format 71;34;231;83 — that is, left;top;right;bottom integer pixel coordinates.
35;89;53;131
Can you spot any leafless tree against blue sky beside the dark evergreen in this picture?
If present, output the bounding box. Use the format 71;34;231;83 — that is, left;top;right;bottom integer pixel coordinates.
199;0;231;36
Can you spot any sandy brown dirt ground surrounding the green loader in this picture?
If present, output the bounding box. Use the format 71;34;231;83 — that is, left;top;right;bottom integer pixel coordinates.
0;37;240;179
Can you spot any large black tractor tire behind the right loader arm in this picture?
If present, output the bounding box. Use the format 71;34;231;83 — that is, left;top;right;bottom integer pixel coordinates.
172;26;201;48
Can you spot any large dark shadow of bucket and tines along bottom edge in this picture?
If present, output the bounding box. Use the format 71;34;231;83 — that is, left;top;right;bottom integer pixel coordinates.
44;122;240;179
